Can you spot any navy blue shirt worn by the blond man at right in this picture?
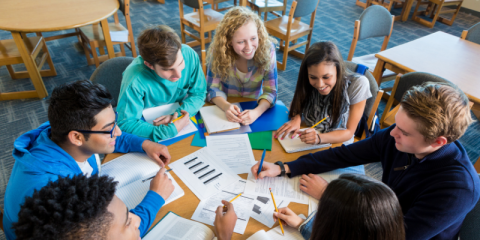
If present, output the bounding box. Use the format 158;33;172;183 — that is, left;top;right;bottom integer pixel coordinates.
287;125;480;239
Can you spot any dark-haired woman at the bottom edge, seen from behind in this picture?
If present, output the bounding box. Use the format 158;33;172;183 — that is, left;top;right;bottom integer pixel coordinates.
274;174;405;240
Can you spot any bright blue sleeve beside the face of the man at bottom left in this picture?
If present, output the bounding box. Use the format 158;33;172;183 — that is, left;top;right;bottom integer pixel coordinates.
130;190;165;237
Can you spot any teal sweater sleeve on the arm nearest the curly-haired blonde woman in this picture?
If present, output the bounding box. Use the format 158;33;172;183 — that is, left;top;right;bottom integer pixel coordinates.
177;50;207;116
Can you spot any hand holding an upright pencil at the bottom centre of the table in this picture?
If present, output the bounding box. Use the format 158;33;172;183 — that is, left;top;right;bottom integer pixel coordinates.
213;200;237;240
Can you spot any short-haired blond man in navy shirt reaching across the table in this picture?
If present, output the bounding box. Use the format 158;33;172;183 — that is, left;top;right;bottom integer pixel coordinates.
252;83;480;239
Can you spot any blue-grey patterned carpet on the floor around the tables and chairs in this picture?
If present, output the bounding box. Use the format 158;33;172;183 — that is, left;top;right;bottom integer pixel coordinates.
0;0;480;237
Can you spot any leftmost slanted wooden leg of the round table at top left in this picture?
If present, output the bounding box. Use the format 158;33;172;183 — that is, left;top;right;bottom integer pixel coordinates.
12;32;48;99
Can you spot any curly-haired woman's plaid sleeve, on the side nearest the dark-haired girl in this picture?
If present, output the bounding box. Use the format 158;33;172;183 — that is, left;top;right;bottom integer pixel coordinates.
257;46;278;107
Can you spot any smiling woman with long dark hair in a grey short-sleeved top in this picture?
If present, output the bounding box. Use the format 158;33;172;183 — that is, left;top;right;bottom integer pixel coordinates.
275;42;372;144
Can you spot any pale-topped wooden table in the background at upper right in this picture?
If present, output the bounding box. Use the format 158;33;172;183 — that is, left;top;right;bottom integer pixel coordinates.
373;32;480;103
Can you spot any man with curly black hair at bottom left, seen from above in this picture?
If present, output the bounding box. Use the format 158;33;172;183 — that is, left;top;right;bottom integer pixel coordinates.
13;174;237;240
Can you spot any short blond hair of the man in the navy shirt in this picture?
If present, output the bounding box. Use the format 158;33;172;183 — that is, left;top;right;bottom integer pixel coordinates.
400;82;473;143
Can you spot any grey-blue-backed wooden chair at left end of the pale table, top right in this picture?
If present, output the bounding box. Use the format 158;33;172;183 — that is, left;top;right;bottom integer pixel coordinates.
347;6;395;77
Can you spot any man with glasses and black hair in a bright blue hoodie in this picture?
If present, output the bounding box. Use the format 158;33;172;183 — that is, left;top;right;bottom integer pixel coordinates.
3;80;173;239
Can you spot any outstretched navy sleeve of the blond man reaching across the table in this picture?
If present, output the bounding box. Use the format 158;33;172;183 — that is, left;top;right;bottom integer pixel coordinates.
286;124;390;177
